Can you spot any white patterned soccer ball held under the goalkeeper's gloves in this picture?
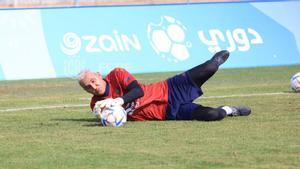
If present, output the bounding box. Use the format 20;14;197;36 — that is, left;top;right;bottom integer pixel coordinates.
100;105;127;127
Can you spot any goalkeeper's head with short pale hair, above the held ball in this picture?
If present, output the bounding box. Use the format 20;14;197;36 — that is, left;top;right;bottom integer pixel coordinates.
80;71;106;96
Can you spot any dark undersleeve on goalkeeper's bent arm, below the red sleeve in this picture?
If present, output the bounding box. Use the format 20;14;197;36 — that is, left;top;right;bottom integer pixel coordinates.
121;80;144;104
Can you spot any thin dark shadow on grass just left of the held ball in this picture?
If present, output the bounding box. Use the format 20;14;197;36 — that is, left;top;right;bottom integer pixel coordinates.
52;118;102;127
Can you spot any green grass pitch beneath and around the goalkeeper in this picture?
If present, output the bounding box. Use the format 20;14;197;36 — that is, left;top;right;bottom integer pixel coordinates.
0;65;300;169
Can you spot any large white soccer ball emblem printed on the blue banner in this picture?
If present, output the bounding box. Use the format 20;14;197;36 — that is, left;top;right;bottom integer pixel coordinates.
147;16;192;63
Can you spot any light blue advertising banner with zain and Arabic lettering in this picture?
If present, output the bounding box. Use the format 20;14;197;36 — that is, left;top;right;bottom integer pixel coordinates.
0;1;300;80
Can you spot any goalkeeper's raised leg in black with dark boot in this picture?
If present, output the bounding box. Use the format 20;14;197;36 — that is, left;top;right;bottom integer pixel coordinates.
188;50;229;88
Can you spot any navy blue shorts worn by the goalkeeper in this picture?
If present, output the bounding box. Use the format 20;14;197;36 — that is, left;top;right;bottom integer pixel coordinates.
166;71;203;120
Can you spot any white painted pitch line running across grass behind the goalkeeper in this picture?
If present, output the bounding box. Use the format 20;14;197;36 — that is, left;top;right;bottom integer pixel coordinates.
0;92;291;112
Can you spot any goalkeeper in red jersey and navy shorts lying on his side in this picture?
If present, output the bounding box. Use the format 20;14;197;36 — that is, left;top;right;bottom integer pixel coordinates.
78;50;251;121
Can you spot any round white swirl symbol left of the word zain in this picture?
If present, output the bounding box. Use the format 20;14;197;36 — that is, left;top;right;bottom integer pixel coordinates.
60;32;81;56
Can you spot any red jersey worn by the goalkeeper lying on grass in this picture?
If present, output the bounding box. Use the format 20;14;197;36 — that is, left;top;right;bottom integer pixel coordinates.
90;68;168;121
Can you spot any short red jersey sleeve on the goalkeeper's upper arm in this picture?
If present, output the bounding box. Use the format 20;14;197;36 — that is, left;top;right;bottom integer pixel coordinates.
114;68;136;89
